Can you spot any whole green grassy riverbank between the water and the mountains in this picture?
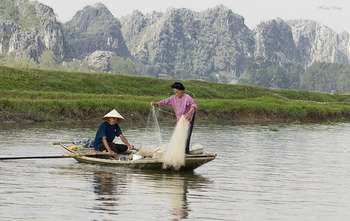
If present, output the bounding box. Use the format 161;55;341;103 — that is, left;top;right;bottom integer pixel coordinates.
0;67;350;123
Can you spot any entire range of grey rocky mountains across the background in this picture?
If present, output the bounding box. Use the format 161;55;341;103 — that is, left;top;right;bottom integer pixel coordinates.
0;0;350;80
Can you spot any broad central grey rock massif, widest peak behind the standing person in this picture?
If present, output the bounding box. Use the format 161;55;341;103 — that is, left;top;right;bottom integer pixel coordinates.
121;6;254;76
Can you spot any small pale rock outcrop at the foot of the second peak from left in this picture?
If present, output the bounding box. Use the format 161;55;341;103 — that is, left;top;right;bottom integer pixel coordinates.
85;51;114;72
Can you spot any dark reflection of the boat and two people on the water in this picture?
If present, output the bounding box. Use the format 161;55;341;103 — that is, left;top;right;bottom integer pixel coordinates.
93;168;211;221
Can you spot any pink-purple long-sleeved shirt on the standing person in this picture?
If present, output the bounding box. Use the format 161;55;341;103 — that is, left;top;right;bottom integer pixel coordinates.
157;94;197;121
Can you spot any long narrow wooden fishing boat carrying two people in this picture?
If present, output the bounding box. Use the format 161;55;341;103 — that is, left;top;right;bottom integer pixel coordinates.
59;142;216;170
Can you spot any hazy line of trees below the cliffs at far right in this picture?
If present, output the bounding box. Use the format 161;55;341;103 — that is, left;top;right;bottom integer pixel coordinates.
239;58;350;93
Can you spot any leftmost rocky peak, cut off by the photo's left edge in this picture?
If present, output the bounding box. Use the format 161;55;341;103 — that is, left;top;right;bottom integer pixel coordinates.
0;0;65;60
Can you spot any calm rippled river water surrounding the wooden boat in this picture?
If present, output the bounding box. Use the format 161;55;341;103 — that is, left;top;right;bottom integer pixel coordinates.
0;121;350;221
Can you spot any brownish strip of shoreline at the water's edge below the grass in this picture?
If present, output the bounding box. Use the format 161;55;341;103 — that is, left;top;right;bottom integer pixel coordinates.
0;110;350;126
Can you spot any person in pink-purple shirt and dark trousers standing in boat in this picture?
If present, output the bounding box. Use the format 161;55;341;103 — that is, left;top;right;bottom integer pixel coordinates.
151;82;197;153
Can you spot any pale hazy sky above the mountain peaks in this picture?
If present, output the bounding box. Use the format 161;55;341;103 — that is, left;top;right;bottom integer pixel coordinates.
38;0;350;32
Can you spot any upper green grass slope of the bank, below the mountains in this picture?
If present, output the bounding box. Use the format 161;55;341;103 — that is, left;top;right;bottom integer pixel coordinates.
0;67;280;99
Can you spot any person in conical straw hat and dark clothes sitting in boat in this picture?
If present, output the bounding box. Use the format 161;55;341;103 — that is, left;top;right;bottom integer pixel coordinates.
94;109;133;160
